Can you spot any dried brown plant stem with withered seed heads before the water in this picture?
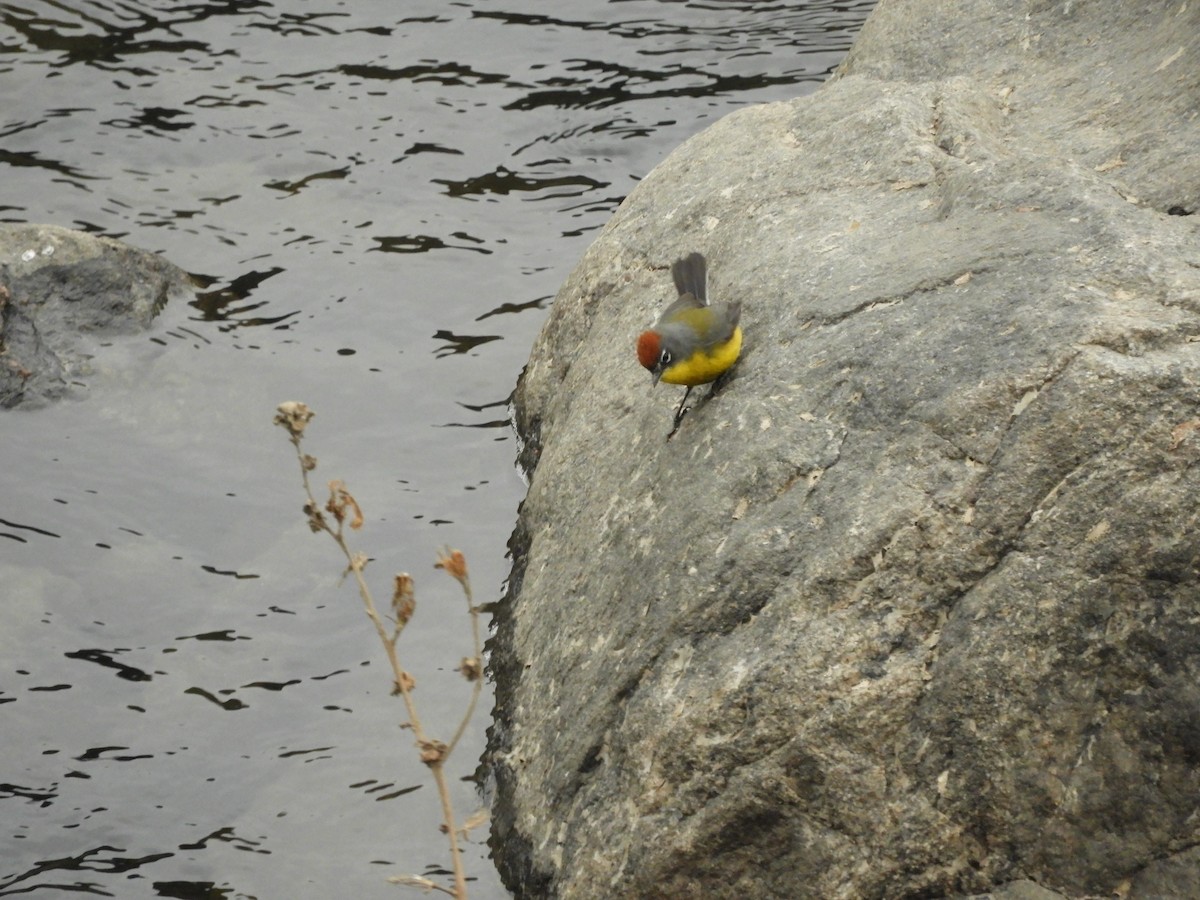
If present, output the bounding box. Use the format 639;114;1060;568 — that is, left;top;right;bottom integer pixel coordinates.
275;403;482;900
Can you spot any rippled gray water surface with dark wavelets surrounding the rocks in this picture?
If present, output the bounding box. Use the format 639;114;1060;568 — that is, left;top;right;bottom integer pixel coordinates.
0;0;871;899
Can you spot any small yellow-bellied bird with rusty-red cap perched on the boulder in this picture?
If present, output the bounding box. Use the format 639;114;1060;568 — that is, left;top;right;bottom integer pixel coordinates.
637;253;742;437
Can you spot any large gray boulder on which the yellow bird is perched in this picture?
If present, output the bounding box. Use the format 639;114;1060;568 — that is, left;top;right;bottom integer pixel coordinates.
492;0;1200;899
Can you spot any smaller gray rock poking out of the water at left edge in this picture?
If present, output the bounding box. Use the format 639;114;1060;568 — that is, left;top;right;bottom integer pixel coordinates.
0;224;188;407
